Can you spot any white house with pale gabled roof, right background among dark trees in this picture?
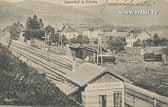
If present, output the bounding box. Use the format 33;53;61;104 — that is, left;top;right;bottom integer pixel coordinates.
126;30;151;47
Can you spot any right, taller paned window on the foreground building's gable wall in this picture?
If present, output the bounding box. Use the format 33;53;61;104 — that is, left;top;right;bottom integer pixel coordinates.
113;91;122;107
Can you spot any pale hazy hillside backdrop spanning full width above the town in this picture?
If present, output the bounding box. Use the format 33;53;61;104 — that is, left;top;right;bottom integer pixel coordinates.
0;0;168;26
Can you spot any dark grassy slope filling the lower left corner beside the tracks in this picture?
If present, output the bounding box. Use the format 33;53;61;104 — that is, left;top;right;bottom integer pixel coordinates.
0;45;79;107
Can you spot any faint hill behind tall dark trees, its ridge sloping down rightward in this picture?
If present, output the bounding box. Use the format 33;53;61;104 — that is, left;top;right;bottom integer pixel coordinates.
0;1;99;25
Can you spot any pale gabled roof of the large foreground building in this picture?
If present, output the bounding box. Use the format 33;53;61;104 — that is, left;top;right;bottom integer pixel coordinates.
66;63;130;87
